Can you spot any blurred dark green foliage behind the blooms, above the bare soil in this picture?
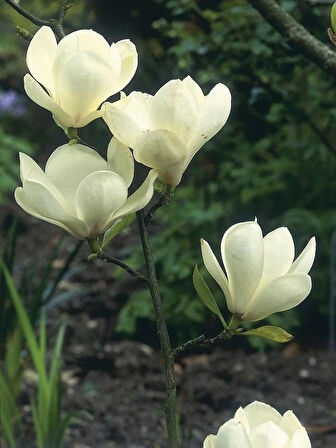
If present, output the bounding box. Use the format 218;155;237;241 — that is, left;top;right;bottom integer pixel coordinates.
0;0;336;343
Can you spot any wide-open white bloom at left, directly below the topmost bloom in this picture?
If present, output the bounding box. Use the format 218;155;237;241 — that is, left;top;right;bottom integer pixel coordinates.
15;139;157;239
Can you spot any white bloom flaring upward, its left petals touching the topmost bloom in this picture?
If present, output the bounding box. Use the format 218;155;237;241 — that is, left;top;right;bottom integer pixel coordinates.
103;76;231;186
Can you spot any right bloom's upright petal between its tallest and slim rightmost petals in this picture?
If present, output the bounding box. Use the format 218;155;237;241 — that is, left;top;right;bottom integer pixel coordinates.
259;227;294;288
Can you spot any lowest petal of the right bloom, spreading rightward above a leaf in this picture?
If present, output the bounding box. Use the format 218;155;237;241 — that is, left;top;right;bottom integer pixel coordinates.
242;272;312;322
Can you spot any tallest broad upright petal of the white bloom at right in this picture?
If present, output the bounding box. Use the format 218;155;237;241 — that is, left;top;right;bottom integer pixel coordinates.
221;221;264;315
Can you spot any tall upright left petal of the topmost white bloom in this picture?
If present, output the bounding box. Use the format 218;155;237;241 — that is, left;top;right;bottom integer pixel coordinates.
26;26;57;95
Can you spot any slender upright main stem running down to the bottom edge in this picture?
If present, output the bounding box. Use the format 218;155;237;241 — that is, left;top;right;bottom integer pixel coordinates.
137;210;179;448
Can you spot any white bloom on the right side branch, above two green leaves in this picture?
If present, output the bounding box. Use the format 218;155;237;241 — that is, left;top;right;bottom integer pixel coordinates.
201;221;316;322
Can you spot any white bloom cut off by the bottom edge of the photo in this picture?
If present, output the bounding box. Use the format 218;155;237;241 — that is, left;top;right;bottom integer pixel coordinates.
203;401;311;448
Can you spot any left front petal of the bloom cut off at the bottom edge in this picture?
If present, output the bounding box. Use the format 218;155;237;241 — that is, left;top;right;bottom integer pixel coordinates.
214;419;252;448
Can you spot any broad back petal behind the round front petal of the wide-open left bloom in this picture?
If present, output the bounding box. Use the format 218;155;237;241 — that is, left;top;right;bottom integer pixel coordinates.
45;144;107;215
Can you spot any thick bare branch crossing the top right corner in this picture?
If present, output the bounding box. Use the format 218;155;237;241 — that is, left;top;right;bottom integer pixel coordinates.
247;0;336;76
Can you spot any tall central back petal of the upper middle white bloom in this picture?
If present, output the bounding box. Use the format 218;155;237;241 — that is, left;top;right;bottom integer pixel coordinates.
152;79;199;144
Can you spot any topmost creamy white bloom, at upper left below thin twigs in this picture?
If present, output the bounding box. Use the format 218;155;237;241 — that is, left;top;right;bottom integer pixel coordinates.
24;26;138;128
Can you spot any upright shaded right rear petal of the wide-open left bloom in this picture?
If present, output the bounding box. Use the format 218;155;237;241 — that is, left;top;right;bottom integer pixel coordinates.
107;137;134;187
